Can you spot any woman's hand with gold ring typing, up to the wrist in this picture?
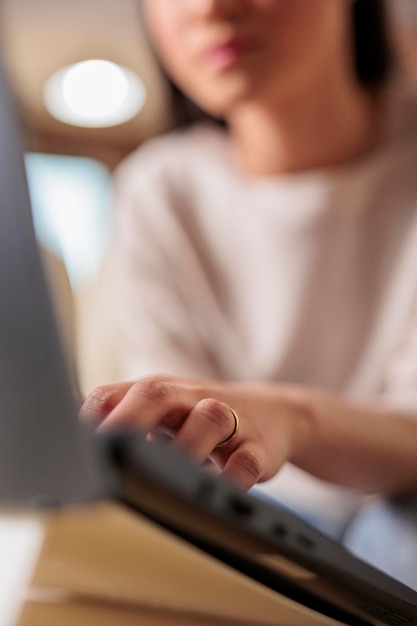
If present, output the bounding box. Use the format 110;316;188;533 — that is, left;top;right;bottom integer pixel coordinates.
81;376;312;489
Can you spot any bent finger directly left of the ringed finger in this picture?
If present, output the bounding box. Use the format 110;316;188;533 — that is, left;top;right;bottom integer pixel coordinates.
97;378;196;432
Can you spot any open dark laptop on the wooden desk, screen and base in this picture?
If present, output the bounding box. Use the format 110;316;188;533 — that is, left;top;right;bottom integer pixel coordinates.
0;57;417;626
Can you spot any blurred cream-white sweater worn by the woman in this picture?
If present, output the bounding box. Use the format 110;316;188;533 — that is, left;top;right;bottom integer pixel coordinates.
102;84;417;532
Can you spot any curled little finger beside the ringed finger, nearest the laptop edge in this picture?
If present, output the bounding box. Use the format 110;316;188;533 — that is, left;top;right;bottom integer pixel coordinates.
222;442;265;490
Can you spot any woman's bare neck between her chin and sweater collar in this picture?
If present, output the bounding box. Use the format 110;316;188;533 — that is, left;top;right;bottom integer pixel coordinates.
228;66;378;176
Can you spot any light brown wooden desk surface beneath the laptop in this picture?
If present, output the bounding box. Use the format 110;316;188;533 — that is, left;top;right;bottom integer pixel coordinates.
4;503;344;626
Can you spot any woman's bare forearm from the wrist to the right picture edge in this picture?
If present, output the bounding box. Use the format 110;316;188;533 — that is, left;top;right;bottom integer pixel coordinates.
292;391;417;494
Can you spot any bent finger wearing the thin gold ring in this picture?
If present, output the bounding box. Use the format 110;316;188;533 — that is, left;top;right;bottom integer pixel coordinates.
174;398;235;463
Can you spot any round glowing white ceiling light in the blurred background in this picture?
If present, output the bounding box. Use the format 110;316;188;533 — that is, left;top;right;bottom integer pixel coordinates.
43;59;147;128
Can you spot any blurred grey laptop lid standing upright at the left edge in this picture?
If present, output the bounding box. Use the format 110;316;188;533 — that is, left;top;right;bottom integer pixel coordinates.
0;58;101;504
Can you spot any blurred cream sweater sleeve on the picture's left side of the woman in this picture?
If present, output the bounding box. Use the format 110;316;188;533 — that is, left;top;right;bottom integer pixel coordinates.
107;146;216;379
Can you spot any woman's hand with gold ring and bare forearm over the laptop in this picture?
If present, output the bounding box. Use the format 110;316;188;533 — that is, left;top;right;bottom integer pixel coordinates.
82;376;417;494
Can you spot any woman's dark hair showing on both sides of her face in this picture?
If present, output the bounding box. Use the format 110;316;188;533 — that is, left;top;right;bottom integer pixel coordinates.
142;0;394;127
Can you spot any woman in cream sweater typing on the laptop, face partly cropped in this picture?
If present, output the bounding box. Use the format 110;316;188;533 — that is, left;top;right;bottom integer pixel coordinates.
84;0;417;536
